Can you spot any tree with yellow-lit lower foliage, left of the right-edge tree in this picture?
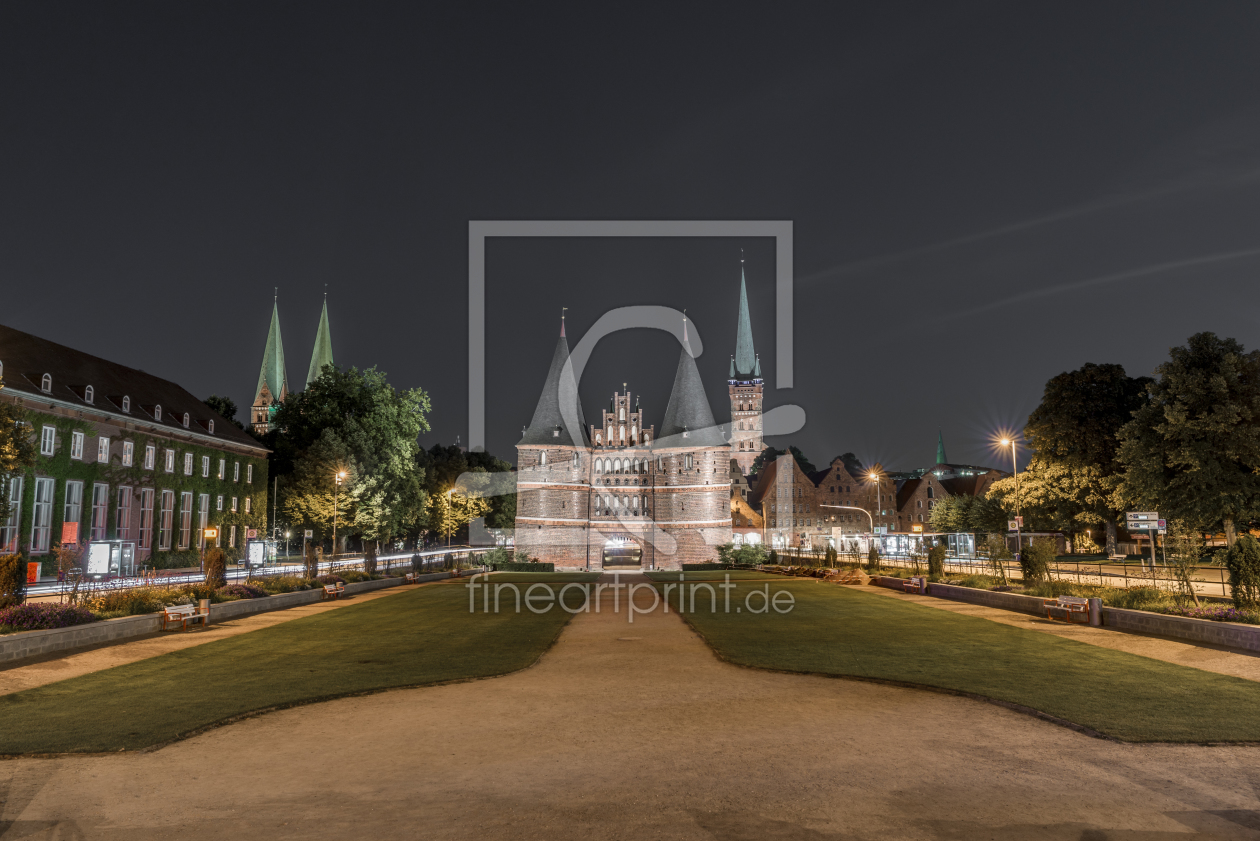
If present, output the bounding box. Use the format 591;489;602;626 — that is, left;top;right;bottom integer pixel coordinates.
1019;362;1150;554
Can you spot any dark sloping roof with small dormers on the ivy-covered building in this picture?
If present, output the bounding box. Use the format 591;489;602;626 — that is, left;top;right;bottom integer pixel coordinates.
0;324;265;450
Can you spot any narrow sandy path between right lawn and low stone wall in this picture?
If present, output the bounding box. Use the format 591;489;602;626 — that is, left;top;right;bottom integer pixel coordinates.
862;586;1260;681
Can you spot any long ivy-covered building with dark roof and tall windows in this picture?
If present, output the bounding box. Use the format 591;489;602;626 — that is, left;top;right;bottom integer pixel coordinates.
0;327;267;576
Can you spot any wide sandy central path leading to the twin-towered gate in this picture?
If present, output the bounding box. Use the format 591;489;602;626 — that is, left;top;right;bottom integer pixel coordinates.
0;576;1260;841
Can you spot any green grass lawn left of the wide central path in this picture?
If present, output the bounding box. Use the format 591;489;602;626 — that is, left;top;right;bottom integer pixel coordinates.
0;575;570;754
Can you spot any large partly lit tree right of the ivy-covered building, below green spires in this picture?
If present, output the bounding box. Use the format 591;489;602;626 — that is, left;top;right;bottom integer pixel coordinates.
266;366;430;549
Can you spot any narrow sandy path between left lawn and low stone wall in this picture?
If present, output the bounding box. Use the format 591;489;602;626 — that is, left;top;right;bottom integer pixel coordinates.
0;584;425;696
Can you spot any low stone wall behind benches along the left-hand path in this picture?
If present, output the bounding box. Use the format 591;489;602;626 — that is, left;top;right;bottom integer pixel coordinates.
0;572;451;663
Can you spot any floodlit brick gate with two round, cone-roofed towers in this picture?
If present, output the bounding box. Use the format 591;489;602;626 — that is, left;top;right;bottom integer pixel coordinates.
515;317;731;570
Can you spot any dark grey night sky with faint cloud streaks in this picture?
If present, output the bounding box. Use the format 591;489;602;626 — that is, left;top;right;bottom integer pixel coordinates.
0;3;1260;469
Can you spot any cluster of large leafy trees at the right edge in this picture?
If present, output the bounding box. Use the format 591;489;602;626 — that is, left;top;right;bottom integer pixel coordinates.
989;333;1260;554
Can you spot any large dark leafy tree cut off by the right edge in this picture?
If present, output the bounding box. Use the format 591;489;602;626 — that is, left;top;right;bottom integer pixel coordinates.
1118;333;1260;546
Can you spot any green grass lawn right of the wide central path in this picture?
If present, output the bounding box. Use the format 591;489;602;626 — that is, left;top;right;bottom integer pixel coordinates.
658;577;1260;741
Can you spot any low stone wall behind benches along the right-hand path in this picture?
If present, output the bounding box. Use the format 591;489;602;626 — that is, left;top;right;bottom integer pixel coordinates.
871;577;1260;652
